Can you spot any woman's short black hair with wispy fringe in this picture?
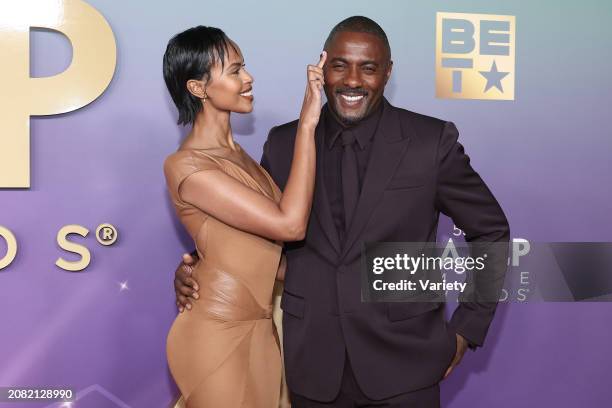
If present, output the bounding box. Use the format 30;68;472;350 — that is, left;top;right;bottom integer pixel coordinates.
163;25;234;125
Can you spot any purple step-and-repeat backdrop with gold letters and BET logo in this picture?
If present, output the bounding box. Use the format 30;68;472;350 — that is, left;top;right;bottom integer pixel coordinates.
0;0;612;408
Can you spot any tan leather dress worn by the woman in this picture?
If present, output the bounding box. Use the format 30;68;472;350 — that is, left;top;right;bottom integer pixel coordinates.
164;148;282;408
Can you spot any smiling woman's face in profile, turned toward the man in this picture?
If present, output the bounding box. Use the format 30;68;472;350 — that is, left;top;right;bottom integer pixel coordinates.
204;41;253;113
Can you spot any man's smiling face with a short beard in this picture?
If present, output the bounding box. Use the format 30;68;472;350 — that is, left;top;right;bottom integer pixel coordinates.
323;32;393;125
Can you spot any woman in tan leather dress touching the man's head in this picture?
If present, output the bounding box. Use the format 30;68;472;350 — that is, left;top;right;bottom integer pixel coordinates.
163;26;326;408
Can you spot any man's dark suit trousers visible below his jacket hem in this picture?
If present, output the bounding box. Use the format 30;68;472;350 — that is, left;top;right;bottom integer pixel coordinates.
289;352;440;408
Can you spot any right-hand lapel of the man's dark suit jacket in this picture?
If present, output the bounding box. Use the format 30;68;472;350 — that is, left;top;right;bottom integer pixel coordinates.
341;99;412;258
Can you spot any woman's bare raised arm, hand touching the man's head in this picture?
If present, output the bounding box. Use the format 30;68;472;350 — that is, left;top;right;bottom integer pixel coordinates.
179;52;326;241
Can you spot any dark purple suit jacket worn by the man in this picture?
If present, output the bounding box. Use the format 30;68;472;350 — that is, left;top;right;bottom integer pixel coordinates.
261;99;510;401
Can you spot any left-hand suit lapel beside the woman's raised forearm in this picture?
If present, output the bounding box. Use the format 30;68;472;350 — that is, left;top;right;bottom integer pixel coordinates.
313;109;340;253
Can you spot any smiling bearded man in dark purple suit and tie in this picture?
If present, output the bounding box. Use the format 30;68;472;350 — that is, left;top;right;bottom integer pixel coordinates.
175;16;510;407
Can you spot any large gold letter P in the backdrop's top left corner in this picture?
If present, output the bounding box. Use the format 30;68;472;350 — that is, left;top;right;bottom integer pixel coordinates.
0;0;117;188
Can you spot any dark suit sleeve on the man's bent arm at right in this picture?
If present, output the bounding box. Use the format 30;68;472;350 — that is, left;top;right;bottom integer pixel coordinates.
436;122;510;349
